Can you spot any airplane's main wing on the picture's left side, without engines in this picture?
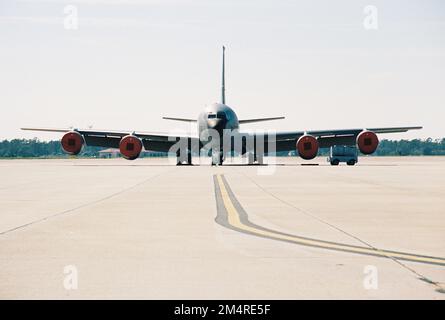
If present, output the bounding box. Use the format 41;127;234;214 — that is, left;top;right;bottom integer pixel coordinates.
21;128;199;152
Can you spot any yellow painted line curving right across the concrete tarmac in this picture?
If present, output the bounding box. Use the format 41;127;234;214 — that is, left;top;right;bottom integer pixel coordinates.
216;174;445;265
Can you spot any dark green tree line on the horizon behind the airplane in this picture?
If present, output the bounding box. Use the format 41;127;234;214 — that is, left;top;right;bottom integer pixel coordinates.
0;138;445;158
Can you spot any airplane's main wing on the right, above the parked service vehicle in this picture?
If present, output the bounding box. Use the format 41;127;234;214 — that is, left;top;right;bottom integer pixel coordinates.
243;126;422;152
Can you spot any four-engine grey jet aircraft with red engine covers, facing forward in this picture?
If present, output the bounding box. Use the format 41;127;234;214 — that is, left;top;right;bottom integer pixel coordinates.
22;47;422;165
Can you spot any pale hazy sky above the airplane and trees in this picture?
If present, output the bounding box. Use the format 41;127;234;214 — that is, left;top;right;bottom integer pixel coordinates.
0;0;445;139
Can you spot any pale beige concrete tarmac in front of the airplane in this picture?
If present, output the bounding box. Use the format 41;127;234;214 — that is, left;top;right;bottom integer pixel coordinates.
0;157;445;299
